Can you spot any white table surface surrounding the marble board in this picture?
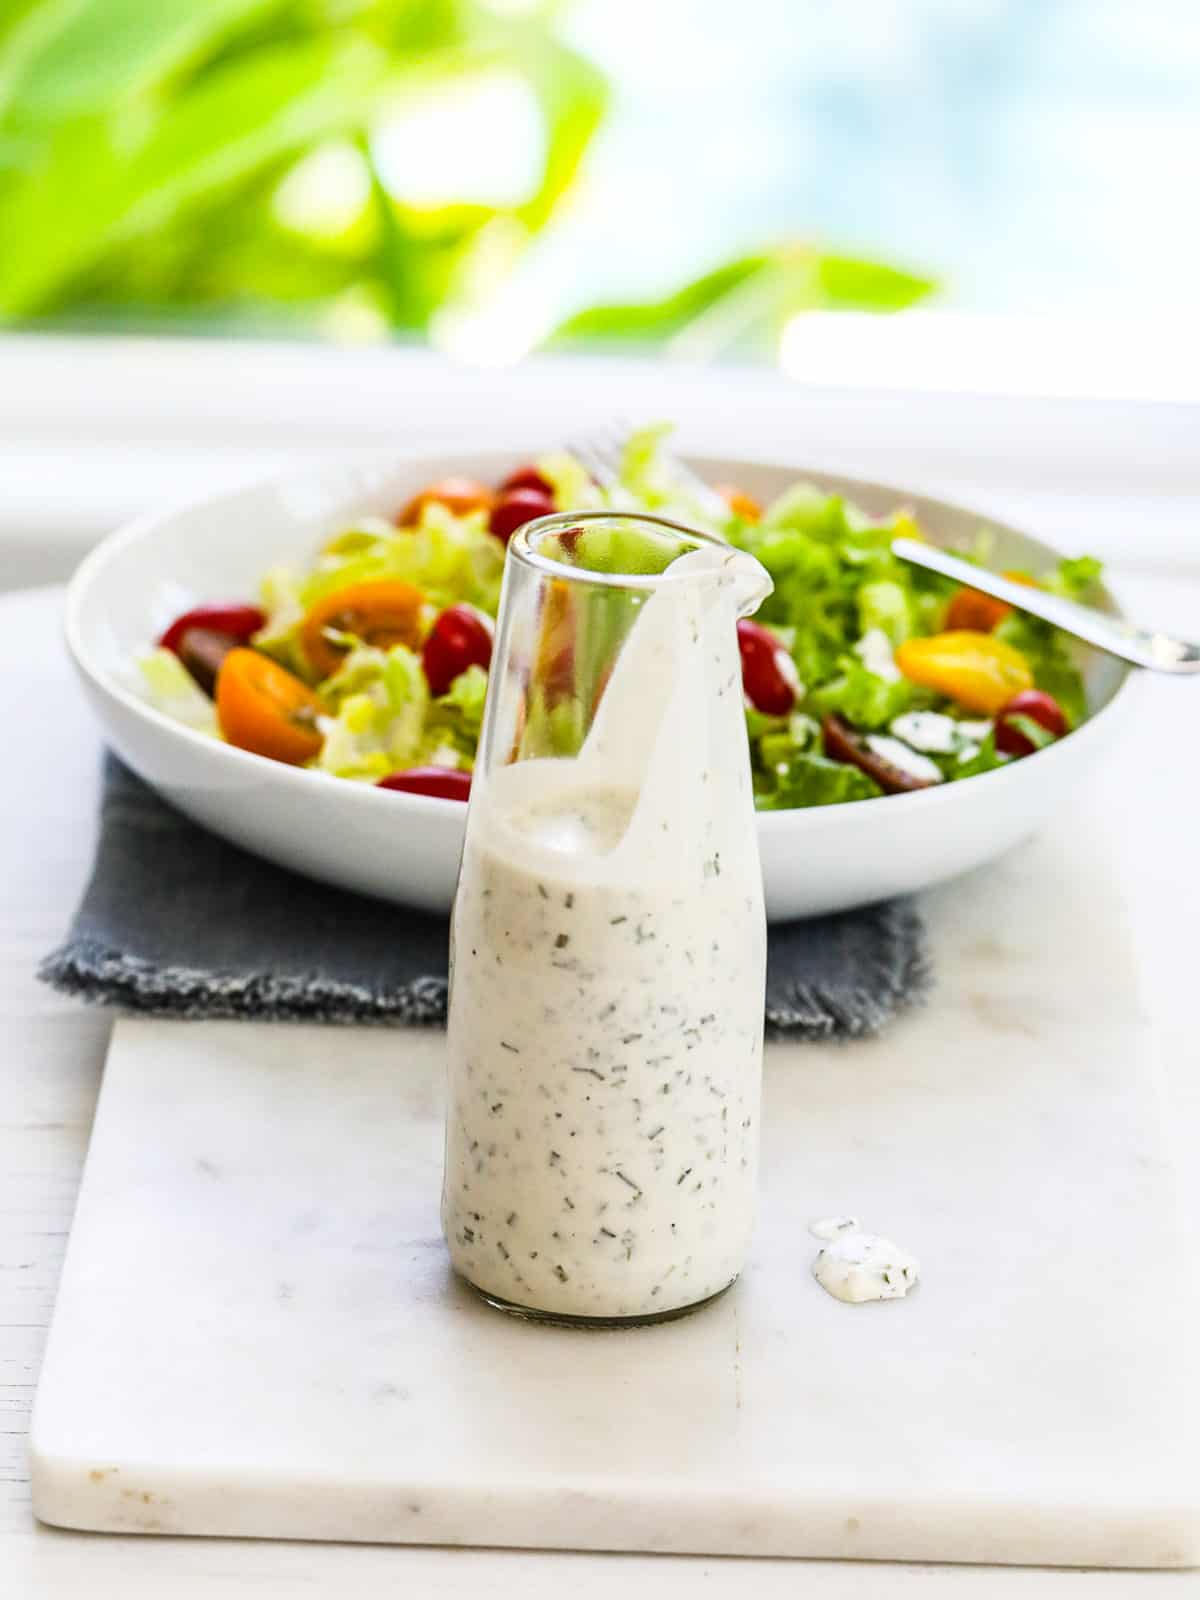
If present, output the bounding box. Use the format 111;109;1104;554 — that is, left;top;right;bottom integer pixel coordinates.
0;547;1200;1600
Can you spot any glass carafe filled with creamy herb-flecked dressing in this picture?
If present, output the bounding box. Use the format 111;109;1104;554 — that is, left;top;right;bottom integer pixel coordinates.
442;512;771;1325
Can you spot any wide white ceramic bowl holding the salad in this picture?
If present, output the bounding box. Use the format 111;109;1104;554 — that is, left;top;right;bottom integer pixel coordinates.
66;451;1131;920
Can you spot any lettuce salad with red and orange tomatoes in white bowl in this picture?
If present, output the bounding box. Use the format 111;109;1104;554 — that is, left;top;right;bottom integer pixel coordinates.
136;427;1099;811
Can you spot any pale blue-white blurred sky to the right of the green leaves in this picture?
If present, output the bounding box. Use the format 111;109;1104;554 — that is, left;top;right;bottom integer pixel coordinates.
538;0;1200;315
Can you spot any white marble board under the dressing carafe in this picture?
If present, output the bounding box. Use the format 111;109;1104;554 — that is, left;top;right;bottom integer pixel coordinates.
32;824;1200;1566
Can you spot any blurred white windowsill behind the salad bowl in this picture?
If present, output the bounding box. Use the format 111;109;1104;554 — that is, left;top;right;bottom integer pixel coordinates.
0;326;1200;587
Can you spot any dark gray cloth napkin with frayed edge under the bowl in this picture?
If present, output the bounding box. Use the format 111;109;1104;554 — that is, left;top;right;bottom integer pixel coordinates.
40;755;930;1038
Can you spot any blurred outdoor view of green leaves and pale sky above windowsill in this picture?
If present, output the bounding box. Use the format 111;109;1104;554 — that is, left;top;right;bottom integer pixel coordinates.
0;0;1200;356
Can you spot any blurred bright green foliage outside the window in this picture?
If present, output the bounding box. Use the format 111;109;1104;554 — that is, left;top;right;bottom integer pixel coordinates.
0;0;930;358
